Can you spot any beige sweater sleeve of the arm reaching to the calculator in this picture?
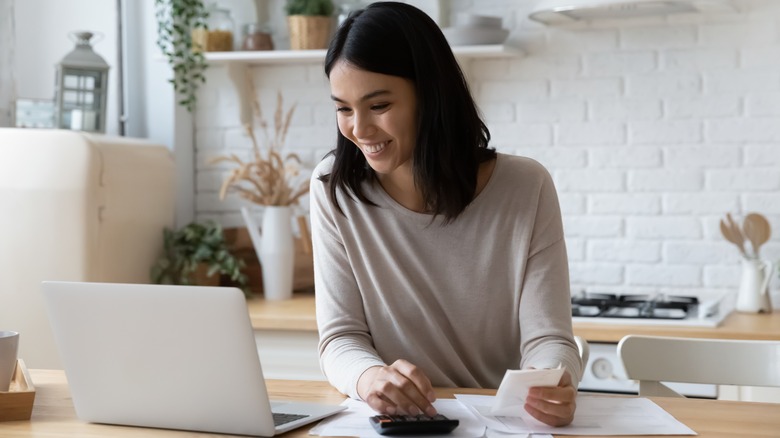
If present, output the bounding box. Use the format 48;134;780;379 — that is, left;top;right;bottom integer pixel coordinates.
310;160;385;399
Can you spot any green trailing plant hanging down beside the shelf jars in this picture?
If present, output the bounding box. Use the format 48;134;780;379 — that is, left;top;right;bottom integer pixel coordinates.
155;0;208;112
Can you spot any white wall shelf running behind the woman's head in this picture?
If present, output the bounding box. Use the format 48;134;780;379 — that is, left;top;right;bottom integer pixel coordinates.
206;44;523;65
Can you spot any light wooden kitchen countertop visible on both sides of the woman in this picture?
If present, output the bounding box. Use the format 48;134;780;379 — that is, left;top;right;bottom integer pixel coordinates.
247;293;780;342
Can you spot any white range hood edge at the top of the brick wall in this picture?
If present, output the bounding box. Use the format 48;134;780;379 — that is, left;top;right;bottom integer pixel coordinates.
529;0;735;25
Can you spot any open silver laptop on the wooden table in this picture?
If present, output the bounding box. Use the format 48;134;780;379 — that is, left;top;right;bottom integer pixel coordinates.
42;282;345;436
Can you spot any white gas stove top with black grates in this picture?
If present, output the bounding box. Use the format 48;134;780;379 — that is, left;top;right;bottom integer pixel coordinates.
571;291;733;327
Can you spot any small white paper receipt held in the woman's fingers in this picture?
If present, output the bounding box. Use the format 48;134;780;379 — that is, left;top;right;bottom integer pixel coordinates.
490;365;564;417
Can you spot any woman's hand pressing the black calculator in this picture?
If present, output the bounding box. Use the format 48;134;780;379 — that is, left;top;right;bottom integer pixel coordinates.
357;359;436;415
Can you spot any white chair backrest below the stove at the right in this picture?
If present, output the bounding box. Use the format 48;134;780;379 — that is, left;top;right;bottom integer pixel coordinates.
618;335;780;397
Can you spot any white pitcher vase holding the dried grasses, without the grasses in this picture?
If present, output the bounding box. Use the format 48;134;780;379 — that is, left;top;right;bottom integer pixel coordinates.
241;206;295;301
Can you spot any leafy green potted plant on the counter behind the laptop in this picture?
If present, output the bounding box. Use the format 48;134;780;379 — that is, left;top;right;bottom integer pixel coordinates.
151;220;249;294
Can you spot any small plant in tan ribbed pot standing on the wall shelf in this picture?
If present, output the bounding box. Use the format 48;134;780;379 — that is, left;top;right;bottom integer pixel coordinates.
285;0;333;50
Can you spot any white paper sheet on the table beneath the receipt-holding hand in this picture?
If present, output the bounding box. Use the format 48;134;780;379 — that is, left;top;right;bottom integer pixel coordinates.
455;394;696;436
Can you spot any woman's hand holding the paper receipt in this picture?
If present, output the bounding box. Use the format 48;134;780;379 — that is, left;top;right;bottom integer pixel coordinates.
525;371;577;426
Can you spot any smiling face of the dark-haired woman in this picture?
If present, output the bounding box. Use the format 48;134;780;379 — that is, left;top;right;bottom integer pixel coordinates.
330;61;417;179
